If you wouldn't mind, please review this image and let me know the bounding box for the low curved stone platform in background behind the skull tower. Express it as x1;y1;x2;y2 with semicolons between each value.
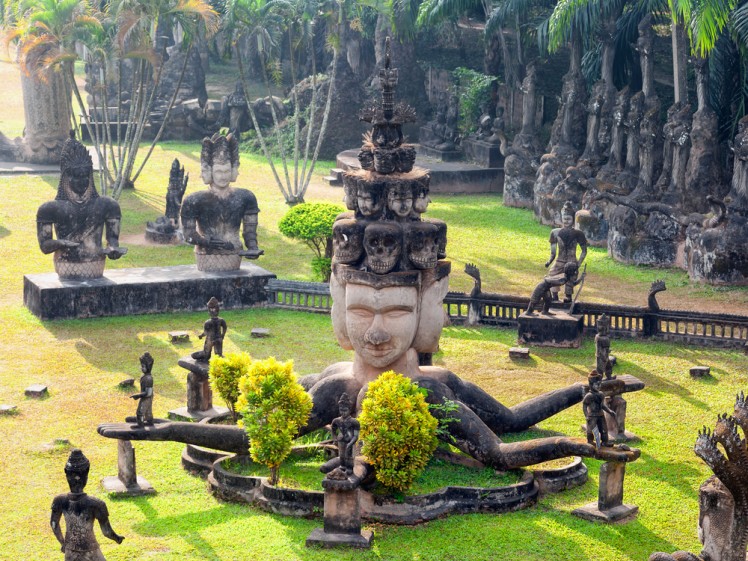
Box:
336;146;504;193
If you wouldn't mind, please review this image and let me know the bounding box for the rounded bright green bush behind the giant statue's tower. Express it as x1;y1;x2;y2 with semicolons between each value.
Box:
278;203;344;282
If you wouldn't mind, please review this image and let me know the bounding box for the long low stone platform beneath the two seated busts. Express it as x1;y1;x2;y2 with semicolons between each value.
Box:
23;262;275;320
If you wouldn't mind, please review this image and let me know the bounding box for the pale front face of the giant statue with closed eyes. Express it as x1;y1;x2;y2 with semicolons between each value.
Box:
345;283;418;368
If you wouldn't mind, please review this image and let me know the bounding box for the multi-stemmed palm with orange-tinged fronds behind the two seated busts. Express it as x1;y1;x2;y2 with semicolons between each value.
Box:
8;0;218;198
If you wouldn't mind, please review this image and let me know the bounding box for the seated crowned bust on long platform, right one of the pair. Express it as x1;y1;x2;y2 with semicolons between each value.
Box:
181;134;264;271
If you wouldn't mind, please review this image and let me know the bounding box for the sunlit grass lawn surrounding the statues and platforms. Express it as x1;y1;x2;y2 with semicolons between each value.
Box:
0;49;748;561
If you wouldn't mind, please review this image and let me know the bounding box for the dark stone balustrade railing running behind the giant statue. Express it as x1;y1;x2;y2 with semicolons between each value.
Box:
266;279;748;347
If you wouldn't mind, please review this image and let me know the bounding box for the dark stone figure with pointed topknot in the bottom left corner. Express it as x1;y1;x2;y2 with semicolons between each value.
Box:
49;449;125;561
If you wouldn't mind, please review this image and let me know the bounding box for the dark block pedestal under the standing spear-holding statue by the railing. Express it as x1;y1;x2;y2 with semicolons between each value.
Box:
517;310;584;349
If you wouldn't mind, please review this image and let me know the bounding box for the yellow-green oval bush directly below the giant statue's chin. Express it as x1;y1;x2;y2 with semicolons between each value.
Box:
358;371;438;491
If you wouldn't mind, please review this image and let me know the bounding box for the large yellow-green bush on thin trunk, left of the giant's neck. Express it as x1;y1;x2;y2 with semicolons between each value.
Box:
236;357;312;485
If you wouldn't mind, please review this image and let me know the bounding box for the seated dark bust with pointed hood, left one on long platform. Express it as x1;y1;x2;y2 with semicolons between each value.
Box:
36;134;127;279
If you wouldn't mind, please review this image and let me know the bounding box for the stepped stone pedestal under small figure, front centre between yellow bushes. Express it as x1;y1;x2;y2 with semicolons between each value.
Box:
306;478;374;548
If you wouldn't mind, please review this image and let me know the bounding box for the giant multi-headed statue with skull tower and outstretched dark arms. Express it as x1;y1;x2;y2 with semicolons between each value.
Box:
99;37;642;469
